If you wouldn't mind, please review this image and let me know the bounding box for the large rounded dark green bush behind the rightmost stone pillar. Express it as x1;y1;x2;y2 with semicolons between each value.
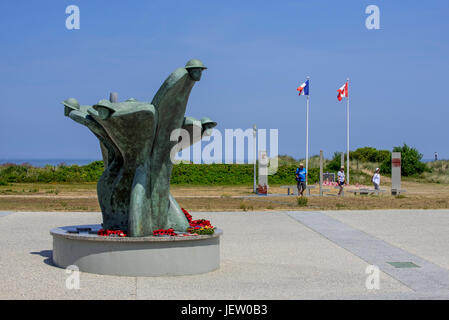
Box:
380;143;429;177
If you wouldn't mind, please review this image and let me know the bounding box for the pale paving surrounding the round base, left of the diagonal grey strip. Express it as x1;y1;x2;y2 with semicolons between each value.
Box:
0;212;412;299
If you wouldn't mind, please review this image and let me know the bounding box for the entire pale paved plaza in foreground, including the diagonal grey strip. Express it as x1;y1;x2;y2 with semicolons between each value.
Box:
0;210;449;299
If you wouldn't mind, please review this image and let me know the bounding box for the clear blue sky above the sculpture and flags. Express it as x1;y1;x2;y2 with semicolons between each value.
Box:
0;0;449;159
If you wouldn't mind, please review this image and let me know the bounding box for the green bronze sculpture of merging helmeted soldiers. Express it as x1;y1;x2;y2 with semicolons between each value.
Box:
63;59;217;237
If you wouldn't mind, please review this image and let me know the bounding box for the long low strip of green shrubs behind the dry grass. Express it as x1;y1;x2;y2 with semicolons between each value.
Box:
0;156;442;186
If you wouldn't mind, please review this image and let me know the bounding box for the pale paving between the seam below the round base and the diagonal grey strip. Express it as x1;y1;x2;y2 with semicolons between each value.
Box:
137;212;411;299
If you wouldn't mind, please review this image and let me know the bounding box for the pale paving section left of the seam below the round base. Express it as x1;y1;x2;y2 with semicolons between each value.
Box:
0;212;136;299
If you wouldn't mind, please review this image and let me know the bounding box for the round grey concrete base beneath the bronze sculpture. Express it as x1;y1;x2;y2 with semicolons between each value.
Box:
50;225;223;277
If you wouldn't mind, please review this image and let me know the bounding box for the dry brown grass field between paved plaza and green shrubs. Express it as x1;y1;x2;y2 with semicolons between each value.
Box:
0;179;449;211
